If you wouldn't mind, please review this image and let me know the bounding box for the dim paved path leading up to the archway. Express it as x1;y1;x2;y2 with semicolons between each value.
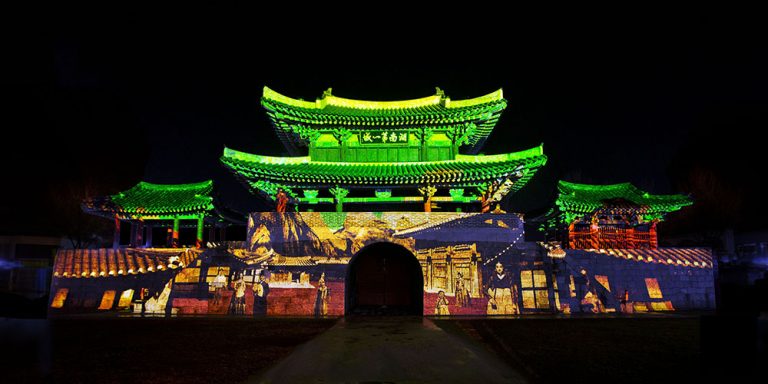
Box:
252;317;526;384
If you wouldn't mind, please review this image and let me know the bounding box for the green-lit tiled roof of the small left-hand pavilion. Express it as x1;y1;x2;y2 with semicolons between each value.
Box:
82;180;214;219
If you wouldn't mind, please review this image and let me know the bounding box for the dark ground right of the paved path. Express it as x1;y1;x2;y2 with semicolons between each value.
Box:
435;315;768;383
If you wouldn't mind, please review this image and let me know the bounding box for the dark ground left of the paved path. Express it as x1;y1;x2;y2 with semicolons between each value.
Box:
0;318;336;383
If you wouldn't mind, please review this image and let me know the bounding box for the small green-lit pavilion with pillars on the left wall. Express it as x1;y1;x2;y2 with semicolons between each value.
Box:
82;180;236;248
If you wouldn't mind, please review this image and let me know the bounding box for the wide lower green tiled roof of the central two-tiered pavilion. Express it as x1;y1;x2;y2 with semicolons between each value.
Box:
221;146;547;192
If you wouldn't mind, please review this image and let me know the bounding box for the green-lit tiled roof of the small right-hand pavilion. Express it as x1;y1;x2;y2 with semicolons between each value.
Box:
555;180;693;215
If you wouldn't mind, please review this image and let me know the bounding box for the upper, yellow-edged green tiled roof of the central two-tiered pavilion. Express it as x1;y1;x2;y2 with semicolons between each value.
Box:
261;87;507;154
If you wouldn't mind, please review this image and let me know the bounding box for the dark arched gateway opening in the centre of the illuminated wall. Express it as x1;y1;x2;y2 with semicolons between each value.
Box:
345;243;424;315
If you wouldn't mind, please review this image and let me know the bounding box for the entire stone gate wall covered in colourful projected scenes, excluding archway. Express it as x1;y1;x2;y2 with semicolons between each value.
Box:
50;212;714;317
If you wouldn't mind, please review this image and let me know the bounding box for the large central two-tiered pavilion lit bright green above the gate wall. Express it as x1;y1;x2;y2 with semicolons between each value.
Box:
221;87;547;211
